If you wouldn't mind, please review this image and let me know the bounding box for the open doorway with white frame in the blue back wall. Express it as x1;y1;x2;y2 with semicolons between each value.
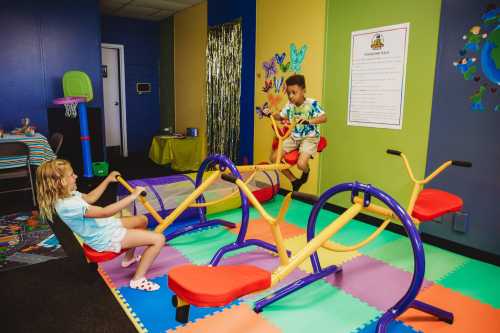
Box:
101;43;128;157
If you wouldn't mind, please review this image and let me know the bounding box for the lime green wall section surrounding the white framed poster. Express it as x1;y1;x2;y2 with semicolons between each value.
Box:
320;0;441;207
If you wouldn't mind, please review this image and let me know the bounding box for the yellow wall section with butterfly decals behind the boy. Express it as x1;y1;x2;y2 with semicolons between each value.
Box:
254;0;328;194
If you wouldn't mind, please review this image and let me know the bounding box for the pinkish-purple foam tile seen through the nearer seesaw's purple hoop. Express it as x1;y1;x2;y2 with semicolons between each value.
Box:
325;255;433;311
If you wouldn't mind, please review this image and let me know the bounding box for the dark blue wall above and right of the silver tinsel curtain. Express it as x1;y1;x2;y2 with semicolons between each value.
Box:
207;0;256;163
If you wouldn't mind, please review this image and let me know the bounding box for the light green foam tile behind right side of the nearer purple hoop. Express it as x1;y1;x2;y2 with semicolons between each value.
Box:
367;237;470;281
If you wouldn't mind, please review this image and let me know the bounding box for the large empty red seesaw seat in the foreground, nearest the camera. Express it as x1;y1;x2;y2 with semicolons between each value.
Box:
168;265;271;307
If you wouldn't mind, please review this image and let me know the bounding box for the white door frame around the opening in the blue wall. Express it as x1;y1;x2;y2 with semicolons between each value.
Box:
101;43;128;157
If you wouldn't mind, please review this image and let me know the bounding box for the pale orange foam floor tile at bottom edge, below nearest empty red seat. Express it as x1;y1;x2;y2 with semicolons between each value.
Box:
167;304;281;333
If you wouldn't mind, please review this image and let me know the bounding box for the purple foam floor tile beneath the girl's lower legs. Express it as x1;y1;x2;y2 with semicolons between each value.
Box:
99;246;189;288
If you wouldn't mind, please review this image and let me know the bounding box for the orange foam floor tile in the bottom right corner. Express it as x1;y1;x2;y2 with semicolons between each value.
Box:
398;281;500;333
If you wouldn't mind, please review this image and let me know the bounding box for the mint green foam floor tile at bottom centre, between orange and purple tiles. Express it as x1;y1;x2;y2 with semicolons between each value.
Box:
261;280;380;333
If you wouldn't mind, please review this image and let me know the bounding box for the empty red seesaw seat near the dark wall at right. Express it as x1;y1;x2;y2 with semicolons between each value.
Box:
412;188;464;222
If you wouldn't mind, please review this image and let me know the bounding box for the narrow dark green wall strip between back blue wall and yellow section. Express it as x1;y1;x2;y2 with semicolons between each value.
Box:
160;16;175;129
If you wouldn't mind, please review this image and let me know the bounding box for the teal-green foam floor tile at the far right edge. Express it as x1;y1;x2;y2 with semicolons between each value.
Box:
438;260;500;309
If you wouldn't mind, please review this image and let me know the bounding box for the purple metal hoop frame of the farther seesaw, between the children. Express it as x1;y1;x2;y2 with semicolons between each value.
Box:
195;154;291;266
